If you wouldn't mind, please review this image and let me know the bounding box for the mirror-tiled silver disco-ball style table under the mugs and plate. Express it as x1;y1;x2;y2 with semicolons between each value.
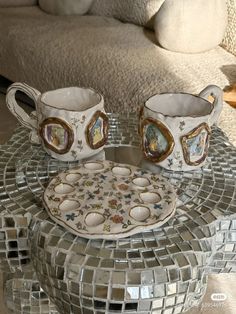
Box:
0;114;236;314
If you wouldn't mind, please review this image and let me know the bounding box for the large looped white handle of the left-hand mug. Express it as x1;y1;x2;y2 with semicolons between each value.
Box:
6;83;41;144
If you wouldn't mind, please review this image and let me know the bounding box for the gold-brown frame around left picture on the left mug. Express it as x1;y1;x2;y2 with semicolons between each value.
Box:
39;117;74;155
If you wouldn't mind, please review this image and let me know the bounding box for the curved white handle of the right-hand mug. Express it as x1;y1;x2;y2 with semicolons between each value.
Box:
199;85;223;126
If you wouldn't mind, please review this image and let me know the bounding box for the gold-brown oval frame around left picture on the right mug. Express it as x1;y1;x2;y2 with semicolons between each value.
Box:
140;118;175;162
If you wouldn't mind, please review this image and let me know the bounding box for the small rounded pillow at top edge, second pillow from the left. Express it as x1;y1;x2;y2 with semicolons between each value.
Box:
39;0;93;15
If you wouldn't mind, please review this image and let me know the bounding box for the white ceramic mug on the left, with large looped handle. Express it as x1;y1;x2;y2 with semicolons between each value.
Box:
6;83;108;161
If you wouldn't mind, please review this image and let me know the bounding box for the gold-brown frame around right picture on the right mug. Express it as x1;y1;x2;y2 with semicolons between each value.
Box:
180;122;211;166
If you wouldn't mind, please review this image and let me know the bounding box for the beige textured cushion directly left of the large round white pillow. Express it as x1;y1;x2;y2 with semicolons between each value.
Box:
90;0;165;28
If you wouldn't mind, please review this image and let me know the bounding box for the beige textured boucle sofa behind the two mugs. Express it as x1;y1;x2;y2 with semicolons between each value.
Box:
0;0;236;112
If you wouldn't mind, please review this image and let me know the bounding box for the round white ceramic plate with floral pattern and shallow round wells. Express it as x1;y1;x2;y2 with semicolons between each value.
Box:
44;161;177;239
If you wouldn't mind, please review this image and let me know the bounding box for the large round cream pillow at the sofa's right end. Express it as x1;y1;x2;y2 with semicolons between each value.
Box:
154;0;227;53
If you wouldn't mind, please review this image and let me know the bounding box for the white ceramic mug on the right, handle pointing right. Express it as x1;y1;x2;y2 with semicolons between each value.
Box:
139;85;223;171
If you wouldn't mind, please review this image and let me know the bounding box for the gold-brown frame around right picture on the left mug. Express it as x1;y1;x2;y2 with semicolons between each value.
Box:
85;110;109;149
